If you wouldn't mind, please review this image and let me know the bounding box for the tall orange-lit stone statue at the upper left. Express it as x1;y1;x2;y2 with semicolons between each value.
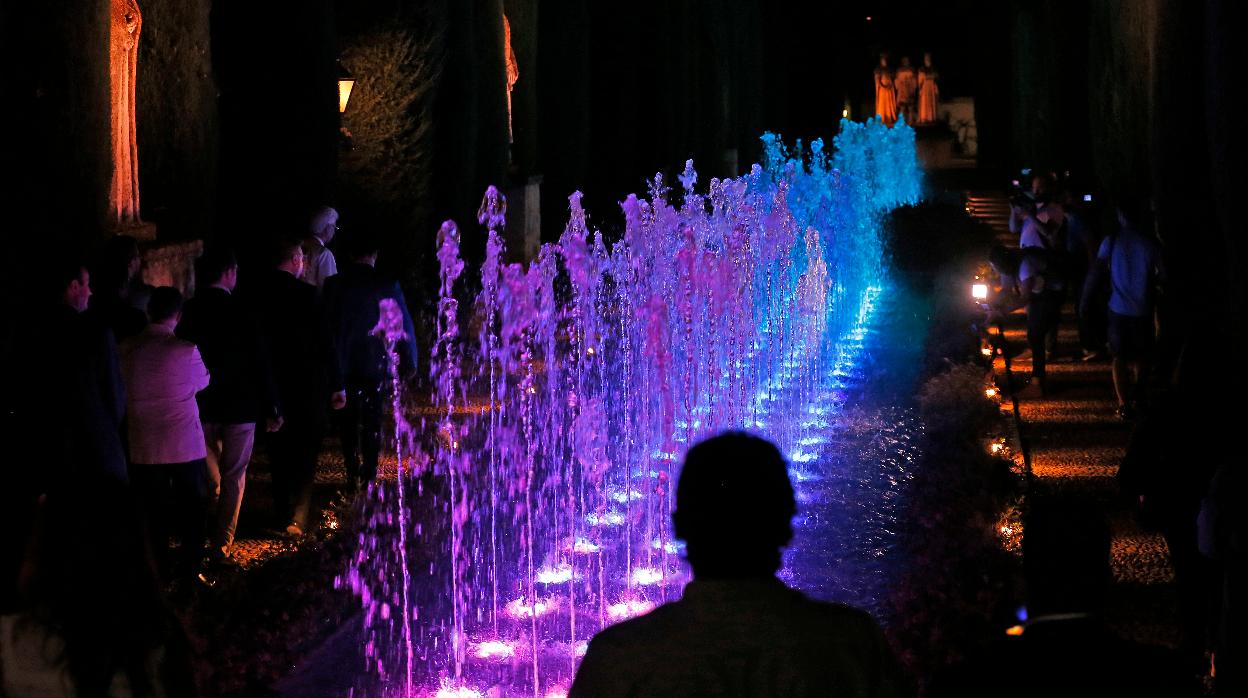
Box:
109;0;144;230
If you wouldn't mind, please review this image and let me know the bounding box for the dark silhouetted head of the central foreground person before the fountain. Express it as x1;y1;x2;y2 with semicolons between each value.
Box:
671;432;797;579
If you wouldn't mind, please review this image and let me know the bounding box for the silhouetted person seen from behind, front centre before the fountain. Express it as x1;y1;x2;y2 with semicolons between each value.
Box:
569;432;896;698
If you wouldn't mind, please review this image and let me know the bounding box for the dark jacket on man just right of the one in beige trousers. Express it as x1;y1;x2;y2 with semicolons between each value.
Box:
247;270;343;428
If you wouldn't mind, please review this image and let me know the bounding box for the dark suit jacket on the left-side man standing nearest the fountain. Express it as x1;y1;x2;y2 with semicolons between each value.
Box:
324;262;416;383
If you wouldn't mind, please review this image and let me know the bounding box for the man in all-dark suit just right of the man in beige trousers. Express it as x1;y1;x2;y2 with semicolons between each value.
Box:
245;241;347;536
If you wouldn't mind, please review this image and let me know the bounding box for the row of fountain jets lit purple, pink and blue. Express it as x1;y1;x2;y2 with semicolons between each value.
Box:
341;121;919;698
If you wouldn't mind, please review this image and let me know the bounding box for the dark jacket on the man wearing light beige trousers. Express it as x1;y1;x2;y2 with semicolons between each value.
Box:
177;286;277;425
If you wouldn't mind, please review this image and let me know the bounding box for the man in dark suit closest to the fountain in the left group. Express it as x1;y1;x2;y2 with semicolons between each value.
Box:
324;233;416;492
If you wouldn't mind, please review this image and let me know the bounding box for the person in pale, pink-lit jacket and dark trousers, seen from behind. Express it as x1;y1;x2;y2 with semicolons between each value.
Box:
121;286;210;577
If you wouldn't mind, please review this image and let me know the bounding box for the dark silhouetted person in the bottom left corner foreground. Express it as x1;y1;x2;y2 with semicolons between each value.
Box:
0;483;197;698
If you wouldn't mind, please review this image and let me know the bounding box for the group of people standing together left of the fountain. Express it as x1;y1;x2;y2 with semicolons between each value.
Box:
0;209;416;696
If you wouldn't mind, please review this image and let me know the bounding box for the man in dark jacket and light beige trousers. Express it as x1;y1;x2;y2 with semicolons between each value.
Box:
177;247;282;564
